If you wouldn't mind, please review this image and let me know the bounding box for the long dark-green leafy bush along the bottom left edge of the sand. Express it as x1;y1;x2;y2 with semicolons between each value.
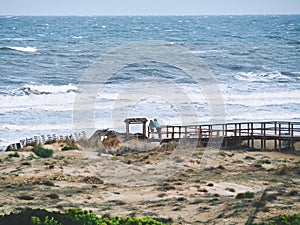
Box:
0;209;169;225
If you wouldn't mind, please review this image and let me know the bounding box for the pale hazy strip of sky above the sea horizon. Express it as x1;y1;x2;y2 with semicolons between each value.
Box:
0;0;300;16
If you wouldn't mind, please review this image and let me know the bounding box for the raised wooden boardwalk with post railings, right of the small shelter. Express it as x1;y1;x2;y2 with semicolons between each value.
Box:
148;121;300;150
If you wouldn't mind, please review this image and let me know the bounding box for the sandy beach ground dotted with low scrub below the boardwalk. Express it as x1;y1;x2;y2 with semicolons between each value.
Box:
0;136;300;224
